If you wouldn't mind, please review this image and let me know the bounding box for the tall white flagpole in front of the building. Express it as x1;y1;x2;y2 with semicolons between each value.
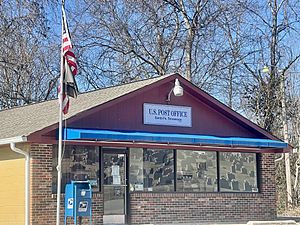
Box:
56;0;64;225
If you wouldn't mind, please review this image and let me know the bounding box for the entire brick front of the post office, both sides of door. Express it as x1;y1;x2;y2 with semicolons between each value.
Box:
30;144;276;225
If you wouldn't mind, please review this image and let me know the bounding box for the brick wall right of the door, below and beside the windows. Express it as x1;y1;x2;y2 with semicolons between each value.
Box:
130;154;276;224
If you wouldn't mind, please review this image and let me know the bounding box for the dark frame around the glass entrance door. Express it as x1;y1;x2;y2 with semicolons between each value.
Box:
99;146;130;224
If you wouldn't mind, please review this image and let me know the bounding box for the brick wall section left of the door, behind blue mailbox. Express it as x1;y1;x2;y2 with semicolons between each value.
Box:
30;144;103;225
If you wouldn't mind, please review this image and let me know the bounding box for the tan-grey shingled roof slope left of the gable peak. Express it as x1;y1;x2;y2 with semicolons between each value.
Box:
0;75;170;144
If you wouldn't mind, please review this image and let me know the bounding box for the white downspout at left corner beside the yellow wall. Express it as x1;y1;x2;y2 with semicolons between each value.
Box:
10;142;30;225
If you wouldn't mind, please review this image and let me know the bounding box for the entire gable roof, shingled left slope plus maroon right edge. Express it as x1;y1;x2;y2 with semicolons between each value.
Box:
0;74;291;151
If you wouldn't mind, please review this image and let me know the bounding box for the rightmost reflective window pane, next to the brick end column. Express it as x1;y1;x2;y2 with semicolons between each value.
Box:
219;152;258;192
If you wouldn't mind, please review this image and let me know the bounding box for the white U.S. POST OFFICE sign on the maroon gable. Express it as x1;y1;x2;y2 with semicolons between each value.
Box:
144;103;192;127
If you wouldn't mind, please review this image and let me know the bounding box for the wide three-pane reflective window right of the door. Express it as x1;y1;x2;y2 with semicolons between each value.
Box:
129;148;258;192
